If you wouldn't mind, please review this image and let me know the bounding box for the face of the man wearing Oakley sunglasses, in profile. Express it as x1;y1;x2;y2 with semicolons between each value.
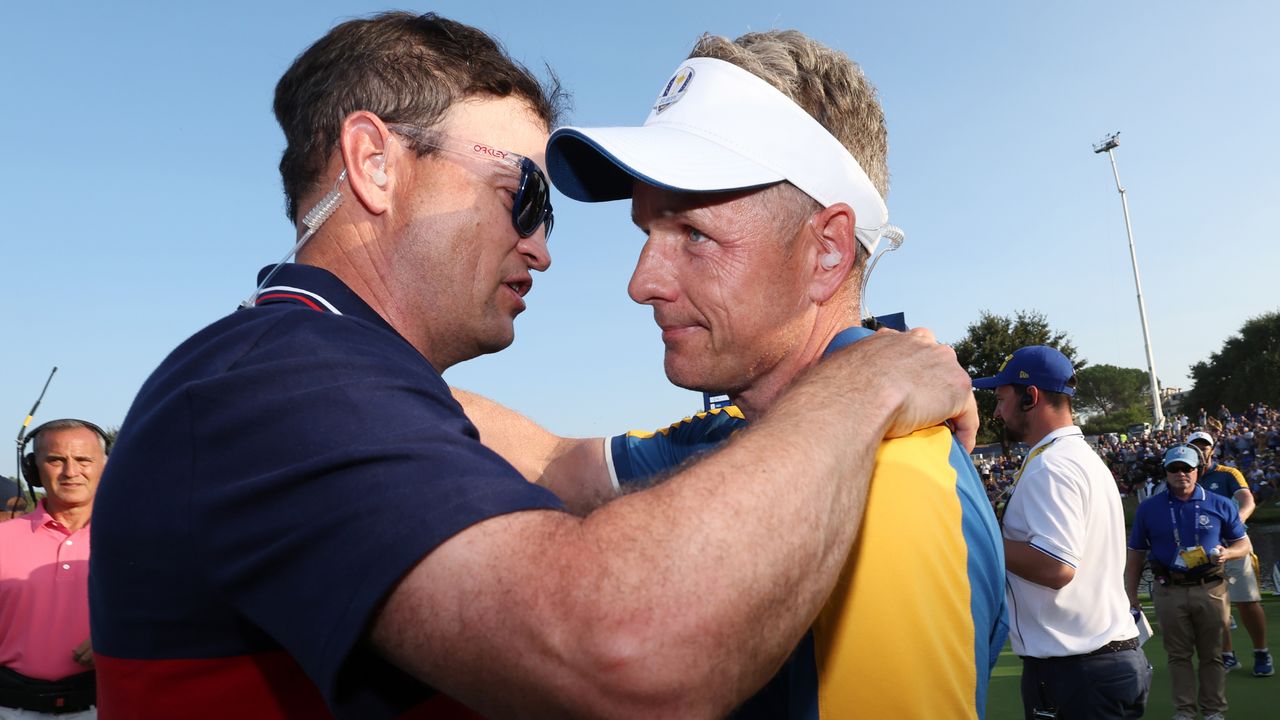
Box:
384;97;550;370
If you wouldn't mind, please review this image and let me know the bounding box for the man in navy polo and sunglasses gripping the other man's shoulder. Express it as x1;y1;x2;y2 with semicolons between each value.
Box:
90;13;975;720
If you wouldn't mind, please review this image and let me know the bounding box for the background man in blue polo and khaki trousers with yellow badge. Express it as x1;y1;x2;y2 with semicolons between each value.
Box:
1124;445;1253;720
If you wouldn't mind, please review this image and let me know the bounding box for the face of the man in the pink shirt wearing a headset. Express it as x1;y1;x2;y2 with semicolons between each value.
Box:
35;428;106;514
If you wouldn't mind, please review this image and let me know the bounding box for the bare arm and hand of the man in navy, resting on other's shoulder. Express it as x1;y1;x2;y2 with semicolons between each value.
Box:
372;334;972;717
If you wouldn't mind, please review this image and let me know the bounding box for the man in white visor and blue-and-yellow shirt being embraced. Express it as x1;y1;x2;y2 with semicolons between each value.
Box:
463;31;1007;719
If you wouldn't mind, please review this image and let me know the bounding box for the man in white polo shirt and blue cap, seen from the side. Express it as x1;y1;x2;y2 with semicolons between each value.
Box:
973;345;1151;720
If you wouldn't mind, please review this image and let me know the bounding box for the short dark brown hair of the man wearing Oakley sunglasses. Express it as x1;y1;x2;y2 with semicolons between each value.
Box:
274;12;566;220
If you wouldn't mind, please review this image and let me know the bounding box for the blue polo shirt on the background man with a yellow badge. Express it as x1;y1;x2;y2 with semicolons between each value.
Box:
1129;486;1244;574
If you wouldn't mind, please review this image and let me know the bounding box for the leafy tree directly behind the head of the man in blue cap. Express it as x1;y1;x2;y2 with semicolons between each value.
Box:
954;310;1085;443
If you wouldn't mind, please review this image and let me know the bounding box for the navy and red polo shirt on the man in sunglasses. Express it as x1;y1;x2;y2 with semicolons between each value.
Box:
90;265;561;719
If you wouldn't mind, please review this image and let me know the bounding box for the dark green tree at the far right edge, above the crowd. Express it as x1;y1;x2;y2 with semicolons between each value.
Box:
1183;311;1280;413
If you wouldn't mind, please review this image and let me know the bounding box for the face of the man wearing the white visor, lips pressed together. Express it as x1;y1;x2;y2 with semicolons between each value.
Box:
627;182;812;395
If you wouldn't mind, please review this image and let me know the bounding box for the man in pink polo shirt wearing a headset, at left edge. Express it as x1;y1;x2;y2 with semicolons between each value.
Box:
0;420;108;720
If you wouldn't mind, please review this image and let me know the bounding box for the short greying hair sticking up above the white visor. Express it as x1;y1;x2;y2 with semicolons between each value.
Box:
689;29;888;197
